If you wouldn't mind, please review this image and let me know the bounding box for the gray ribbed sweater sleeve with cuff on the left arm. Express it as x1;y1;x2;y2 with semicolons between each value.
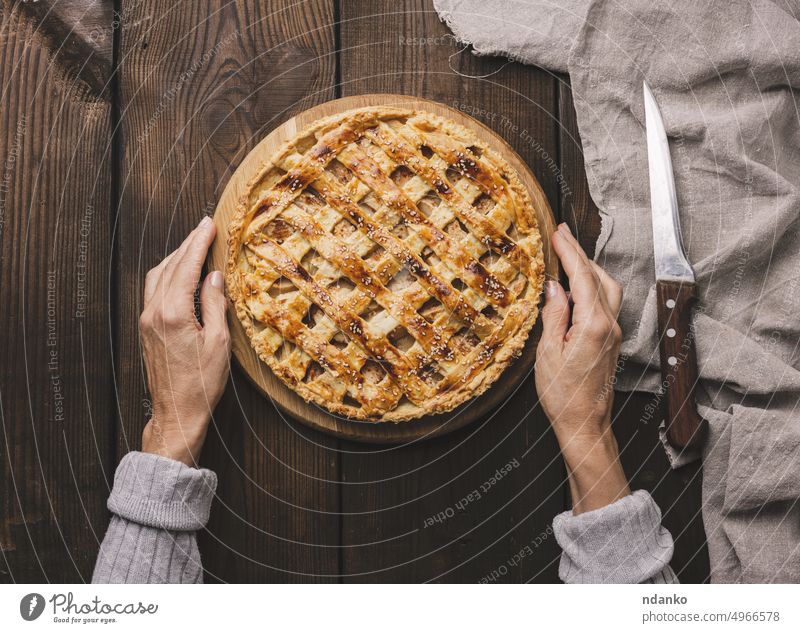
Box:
92;452;217;583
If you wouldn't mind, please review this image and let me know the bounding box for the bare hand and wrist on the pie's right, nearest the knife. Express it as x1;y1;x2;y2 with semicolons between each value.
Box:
536;224;630;514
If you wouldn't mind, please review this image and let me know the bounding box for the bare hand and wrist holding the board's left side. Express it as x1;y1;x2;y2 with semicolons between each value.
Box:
139;218;231;466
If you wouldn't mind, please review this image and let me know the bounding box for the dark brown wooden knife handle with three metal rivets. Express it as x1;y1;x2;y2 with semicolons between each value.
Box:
656;281;708;449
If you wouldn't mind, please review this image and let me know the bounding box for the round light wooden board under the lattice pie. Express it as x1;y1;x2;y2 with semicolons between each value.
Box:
209;94;558;443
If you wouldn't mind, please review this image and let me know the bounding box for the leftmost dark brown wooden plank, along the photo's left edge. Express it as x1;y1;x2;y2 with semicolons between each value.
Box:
0;0;113;583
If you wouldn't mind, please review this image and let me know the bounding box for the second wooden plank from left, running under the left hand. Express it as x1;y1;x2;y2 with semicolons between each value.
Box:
117;0;339;582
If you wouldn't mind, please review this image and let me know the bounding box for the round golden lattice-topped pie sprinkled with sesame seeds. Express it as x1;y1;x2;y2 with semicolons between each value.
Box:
227;107;544;421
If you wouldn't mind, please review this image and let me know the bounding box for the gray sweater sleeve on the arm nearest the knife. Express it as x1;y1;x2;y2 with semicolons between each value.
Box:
553;490;678;584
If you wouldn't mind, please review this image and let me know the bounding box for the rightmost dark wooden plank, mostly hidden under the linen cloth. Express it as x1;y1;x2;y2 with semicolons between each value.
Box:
559;77;709;583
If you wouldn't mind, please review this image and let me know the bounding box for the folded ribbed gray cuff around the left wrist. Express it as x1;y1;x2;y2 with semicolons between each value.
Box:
108;452;217;531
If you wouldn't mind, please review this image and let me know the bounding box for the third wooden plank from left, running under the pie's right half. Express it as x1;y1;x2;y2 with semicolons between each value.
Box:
340;0;564;582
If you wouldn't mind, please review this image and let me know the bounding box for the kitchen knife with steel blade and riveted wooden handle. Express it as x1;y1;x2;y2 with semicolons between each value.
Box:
644;82;708;449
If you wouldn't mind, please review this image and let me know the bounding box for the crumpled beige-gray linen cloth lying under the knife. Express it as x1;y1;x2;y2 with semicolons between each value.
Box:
435;0;800;582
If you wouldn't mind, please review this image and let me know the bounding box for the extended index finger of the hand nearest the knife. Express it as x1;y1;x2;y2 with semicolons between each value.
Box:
552;224;609;323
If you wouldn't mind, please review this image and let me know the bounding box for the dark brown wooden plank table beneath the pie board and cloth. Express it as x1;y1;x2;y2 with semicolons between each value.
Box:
0;0;708;582
